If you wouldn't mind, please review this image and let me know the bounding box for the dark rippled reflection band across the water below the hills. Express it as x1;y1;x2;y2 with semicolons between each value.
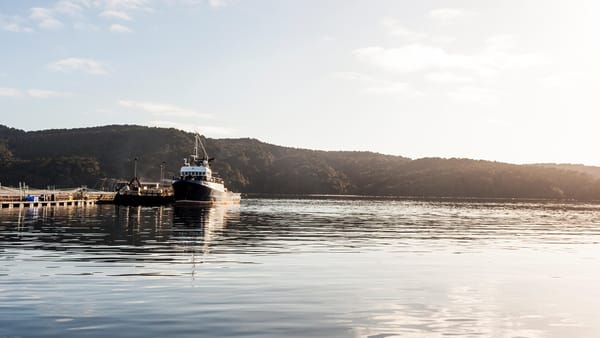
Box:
0;200;600;260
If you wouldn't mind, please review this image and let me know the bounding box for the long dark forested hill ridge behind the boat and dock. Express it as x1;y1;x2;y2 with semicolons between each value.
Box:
0;125;600;200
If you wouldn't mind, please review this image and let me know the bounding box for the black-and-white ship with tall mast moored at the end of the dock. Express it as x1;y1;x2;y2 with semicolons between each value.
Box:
172;133;241;206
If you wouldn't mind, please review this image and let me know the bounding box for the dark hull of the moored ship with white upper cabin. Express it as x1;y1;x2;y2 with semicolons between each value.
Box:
173;180;240;205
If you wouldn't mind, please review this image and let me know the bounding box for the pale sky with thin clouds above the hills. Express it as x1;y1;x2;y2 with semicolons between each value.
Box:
0;0;600;165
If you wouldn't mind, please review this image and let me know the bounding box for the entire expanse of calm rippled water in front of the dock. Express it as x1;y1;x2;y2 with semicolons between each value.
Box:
0;199;600;337
